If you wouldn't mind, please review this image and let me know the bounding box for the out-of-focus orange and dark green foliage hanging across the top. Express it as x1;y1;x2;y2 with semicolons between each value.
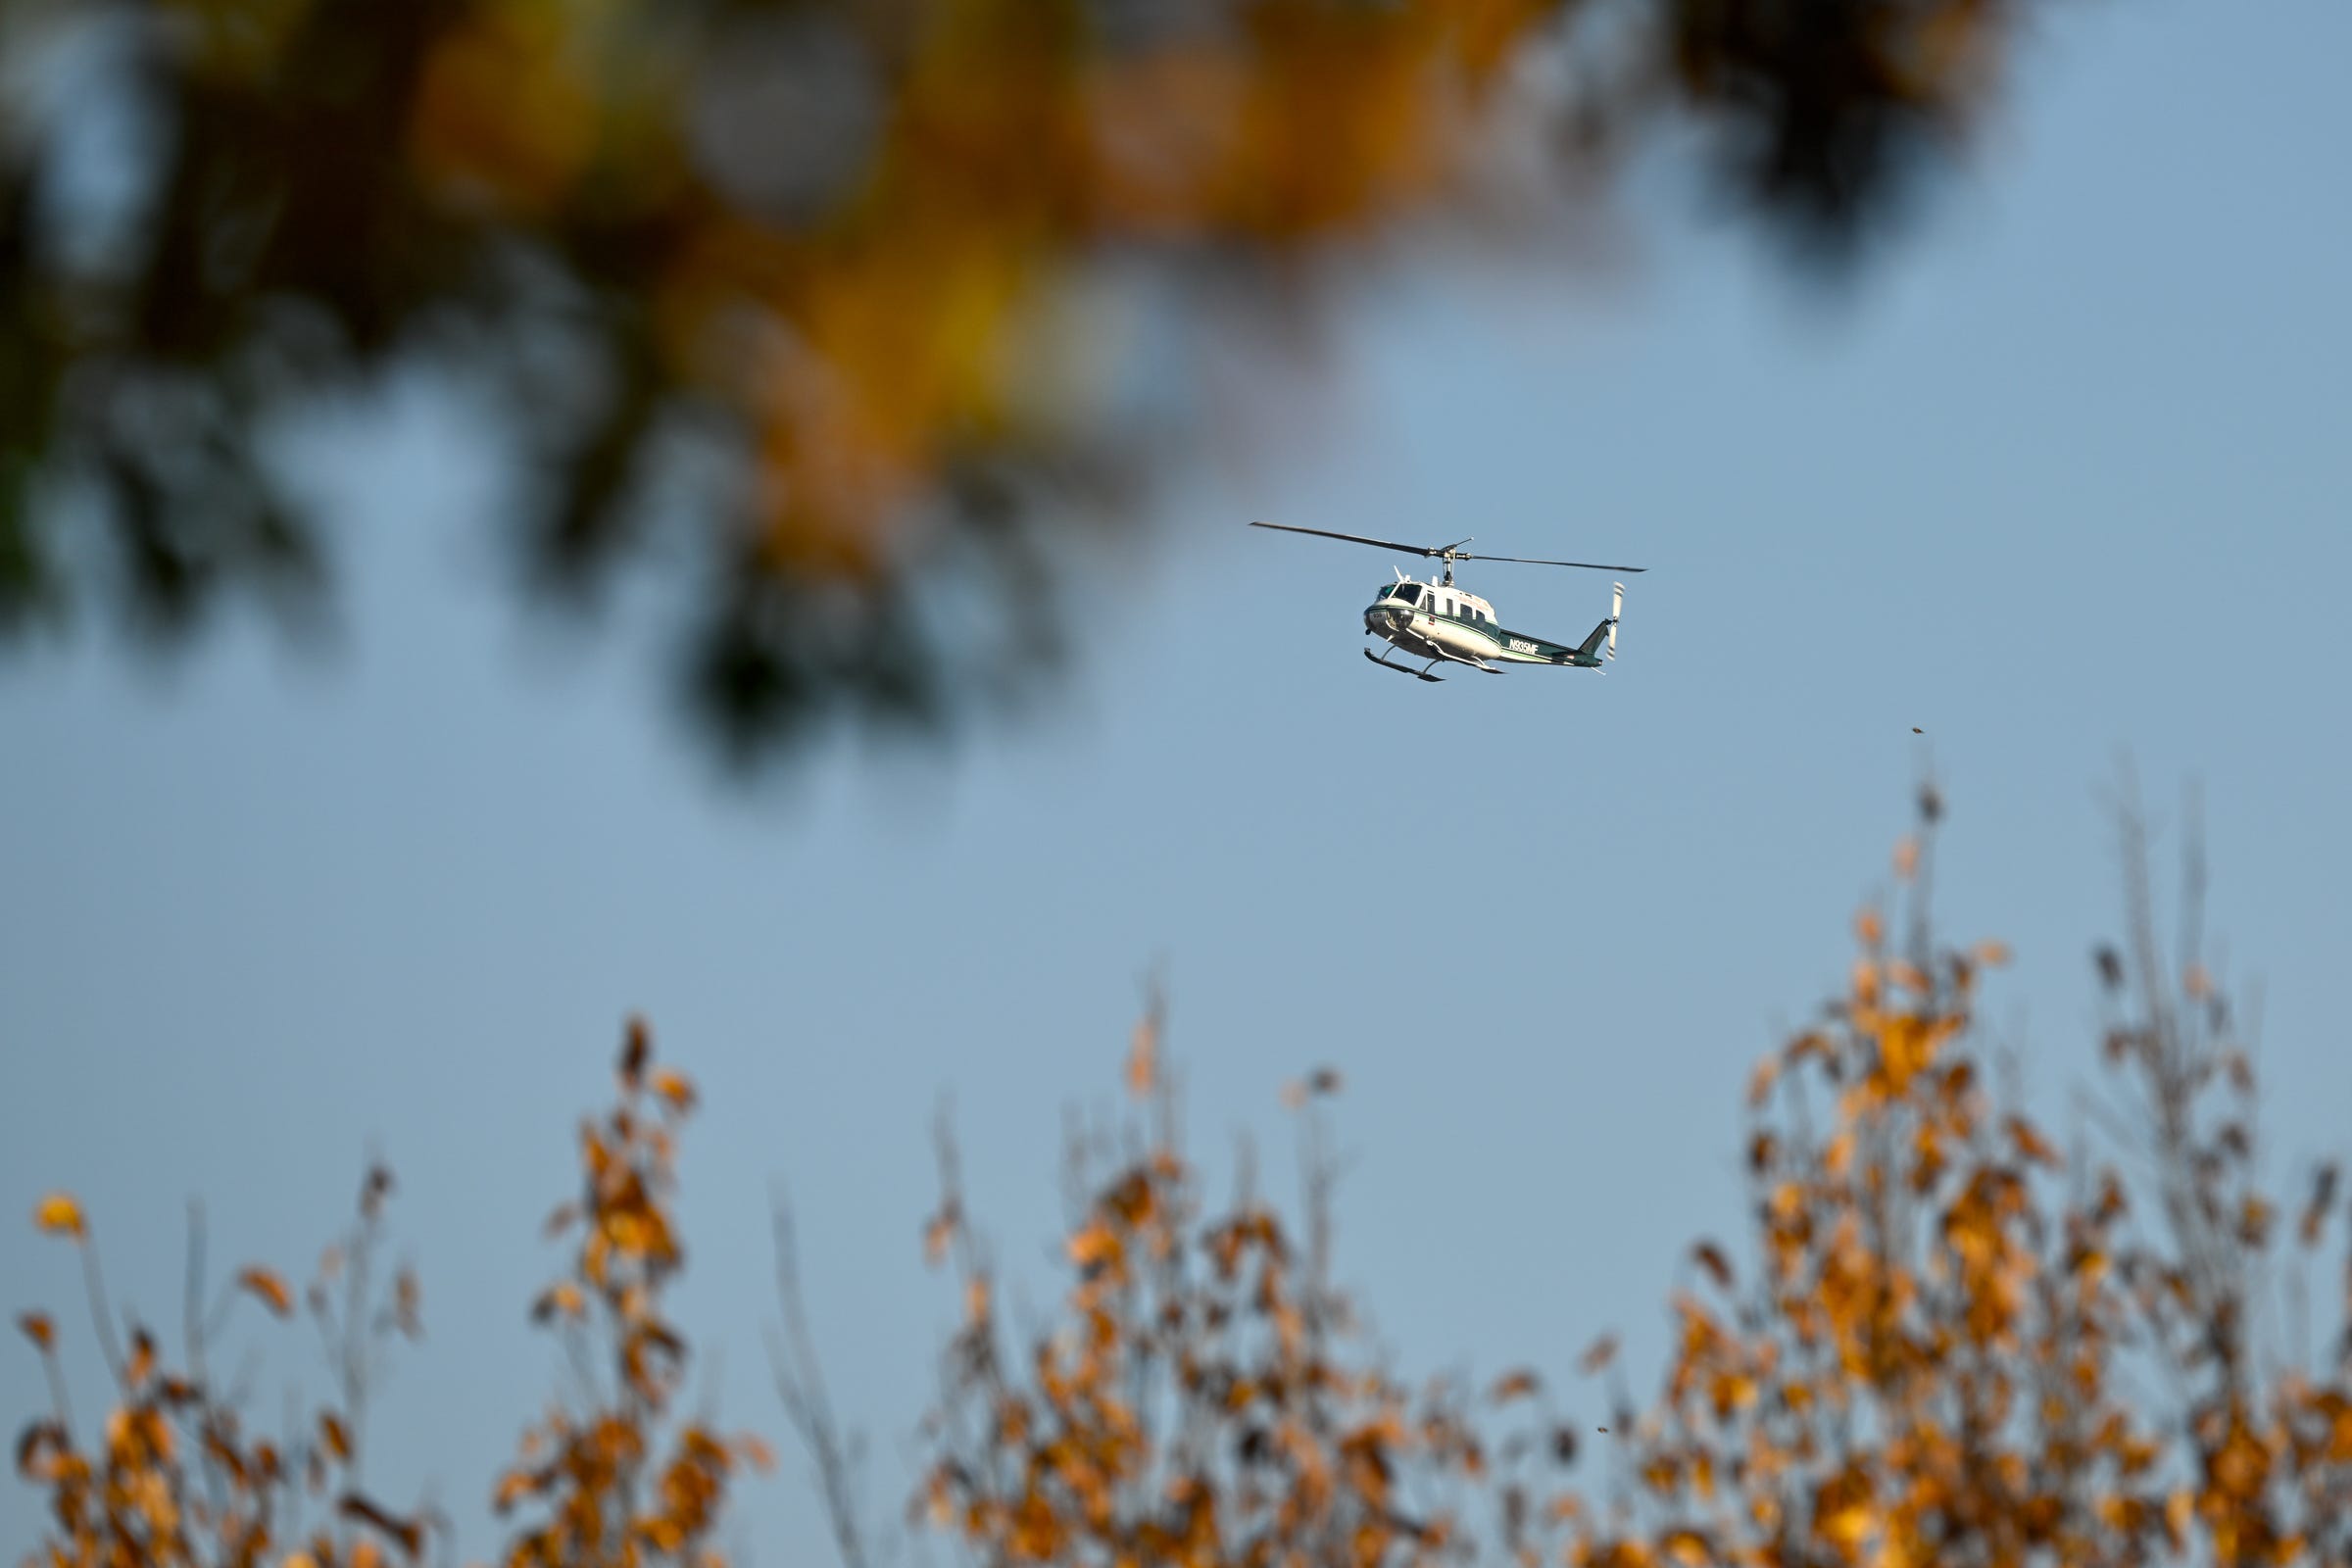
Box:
0;0;2028;757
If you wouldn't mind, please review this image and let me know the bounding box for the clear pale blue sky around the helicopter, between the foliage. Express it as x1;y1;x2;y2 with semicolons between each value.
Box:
0;0;2352;1561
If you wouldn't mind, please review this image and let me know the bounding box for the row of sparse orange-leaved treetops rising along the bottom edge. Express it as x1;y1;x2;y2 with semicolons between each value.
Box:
17;795;2352;1568
